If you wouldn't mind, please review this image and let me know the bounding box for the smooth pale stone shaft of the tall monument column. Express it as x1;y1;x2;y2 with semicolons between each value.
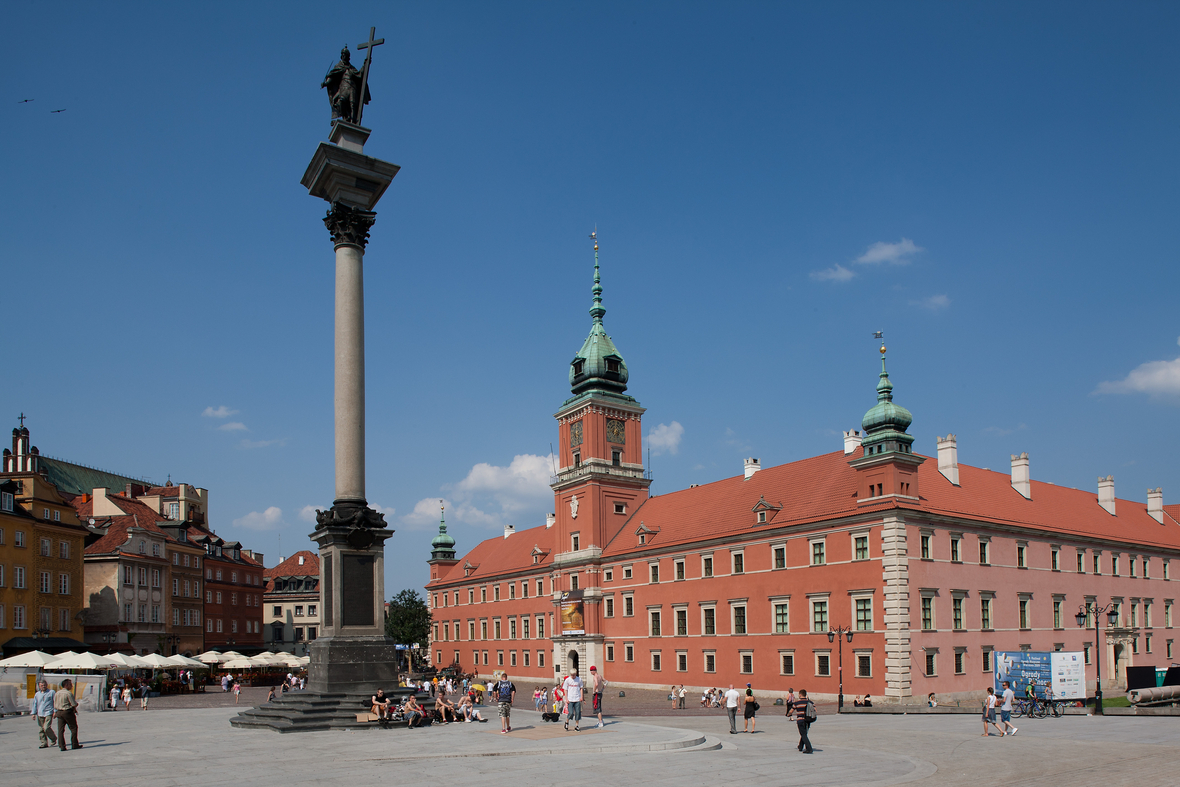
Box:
335;243;365;504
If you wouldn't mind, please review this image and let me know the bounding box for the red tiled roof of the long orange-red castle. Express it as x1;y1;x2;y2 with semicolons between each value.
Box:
438;452;1180;586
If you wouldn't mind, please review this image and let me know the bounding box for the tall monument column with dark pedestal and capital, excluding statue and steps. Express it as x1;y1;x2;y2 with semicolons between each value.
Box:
302;110;399;695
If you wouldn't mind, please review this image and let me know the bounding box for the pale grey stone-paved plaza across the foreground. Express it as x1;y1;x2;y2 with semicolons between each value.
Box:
0;708;1180;787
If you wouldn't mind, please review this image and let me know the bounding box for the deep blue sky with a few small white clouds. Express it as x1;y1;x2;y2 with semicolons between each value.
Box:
0;2;1180;592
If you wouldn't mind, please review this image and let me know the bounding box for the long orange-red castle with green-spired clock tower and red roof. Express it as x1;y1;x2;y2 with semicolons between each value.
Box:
426;247;1180;702
